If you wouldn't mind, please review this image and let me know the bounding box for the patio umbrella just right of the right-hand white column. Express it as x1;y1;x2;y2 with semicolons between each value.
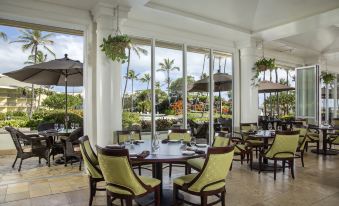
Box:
258;81;294;116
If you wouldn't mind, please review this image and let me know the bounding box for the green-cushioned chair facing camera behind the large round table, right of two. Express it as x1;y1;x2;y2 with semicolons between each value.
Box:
167;129;192;177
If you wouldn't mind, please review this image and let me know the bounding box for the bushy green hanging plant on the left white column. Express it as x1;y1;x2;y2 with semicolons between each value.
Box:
100;35;131;63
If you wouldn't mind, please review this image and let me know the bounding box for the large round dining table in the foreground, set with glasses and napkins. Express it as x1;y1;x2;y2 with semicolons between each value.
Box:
125;140;208;206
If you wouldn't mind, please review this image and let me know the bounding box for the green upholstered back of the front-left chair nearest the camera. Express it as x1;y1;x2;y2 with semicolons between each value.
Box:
98;153;146;195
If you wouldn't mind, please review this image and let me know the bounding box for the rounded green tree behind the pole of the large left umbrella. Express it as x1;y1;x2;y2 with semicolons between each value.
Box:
42;93;83;109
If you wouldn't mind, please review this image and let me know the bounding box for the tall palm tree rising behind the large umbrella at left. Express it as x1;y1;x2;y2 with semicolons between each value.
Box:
10;29;55;117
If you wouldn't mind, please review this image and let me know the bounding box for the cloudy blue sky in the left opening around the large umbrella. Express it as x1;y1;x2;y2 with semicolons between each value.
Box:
0;25;84;92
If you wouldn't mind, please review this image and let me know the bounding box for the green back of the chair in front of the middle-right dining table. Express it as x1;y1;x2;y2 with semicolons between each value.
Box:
265;134;299;158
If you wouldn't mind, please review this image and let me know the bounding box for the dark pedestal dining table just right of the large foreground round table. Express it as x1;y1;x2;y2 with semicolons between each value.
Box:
249;130;275;171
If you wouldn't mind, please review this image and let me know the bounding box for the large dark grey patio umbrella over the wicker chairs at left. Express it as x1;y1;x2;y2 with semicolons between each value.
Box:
4;54;83;128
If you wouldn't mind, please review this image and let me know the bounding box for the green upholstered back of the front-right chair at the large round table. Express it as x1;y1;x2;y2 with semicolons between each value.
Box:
188;150;234;192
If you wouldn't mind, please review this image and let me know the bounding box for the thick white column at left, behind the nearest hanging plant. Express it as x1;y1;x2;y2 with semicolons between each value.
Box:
93;2;122;146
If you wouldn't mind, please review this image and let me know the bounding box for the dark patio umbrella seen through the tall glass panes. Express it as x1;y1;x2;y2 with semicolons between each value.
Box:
188;72;232;115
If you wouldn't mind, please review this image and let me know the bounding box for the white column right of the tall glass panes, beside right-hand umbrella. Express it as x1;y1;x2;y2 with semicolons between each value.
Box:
240;43;258;123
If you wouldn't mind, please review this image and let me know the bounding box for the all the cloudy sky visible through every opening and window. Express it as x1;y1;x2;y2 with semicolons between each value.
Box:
0;25;294;104
